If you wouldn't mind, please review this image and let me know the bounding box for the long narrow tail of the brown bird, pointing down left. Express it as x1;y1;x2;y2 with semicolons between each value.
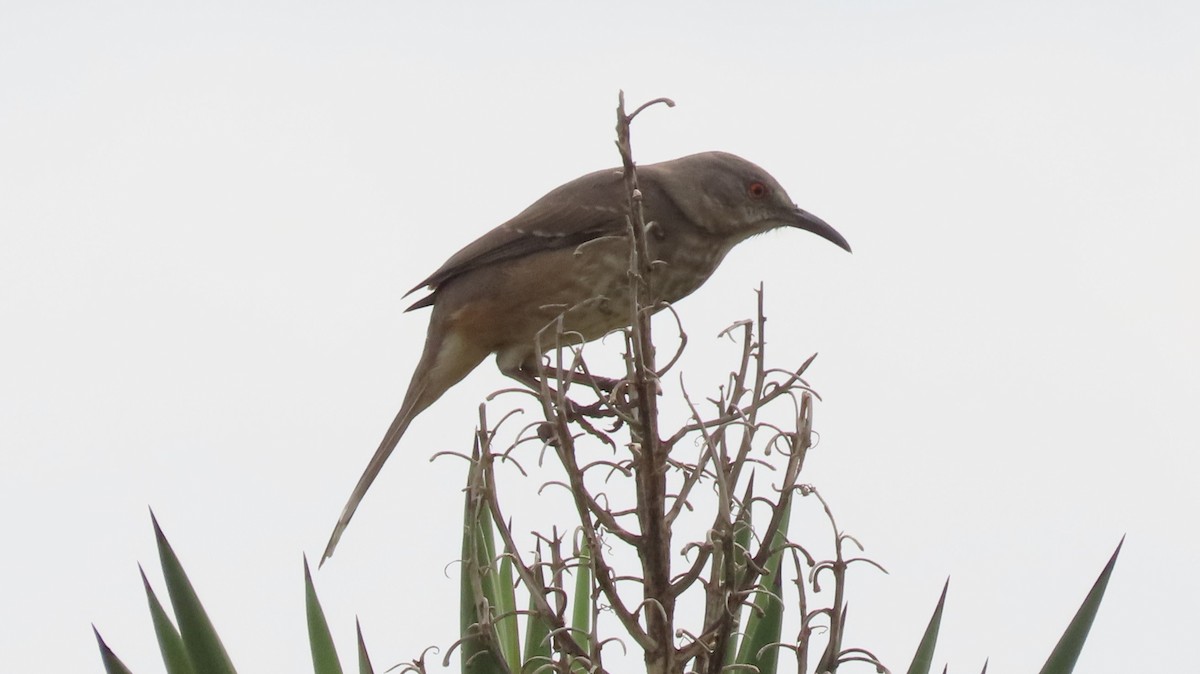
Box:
318;317;487;567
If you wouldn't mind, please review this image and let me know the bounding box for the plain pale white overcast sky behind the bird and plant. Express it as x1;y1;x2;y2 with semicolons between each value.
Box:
0;0;1200;673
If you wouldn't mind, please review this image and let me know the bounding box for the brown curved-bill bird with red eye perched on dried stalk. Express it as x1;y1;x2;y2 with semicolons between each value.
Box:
320;151;851;564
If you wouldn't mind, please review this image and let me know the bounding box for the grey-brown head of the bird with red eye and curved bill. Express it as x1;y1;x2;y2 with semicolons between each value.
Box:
638;152;850;251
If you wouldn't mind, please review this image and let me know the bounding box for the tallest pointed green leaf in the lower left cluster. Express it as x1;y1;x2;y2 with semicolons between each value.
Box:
150;512;236;674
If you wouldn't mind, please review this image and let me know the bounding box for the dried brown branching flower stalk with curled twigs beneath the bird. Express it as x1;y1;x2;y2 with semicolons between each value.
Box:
444;96;886;674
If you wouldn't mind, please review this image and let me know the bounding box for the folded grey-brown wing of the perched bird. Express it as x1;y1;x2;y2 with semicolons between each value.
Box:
407;169;626;311
